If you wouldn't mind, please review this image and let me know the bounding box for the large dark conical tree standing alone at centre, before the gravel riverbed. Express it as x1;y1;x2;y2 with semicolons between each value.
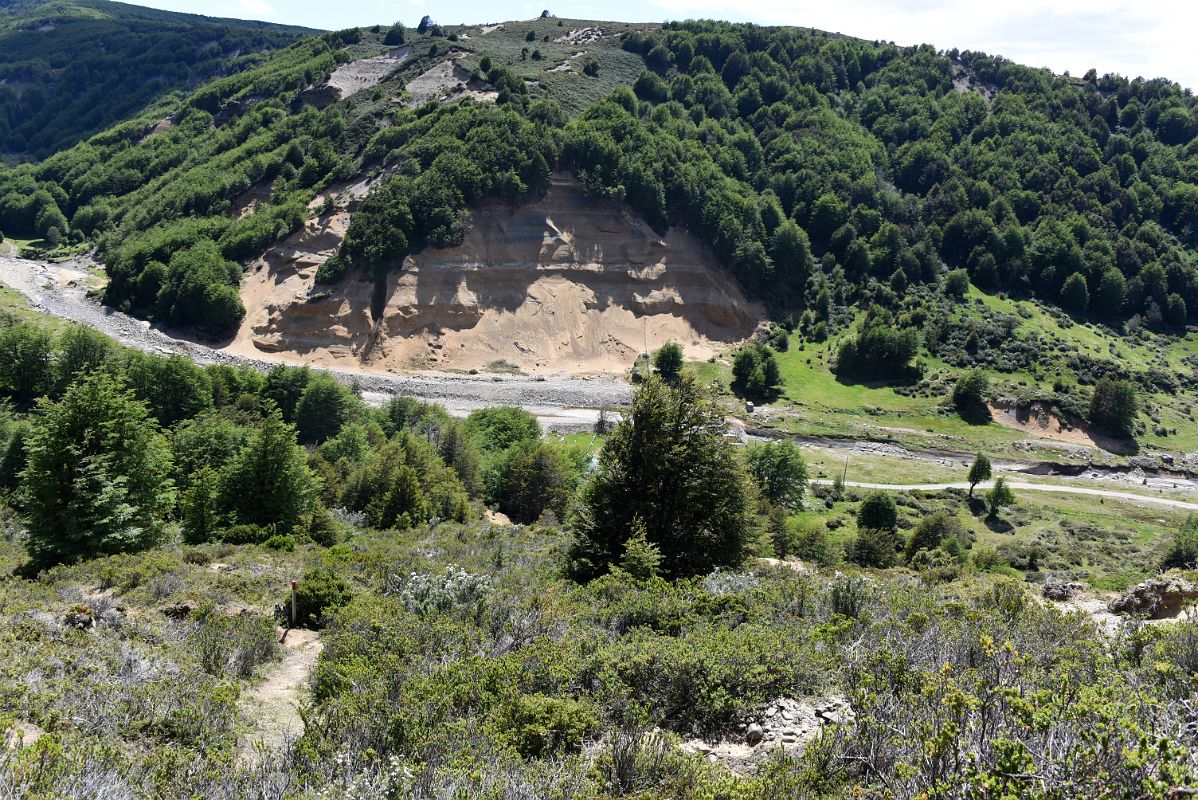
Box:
571;376;757;577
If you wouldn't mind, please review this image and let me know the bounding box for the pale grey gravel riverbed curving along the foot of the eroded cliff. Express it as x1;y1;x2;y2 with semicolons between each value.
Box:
0;253;633;431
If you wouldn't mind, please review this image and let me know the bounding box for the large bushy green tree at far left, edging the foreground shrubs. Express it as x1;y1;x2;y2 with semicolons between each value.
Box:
22;372;175;565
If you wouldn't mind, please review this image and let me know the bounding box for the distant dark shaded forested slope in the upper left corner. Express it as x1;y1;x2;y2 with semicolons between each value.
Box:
0;0;310;158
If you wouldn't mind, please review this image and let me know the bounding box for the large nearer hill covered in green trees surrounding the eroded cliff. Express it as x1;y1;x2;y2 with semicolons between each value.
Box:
0;19;1198;349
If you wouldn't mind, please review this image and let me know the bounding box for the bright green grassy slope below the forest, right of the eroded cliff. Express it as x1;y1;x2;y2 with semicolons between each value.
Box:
688;282;1198;463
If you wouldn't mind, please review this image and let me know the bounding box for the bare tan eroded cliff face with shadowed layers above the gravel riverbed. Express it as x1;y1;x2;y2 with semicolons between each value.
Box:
232;175;764;372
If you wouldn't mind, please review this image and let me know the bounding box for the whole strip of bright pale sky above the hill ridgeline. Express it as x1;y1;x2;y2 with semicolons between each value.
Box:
137;0;1198;91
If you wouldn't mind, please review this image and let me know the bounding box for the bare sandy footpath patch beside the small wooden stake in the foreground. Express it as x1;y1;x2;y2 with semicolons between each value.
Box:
237;629;325;764
